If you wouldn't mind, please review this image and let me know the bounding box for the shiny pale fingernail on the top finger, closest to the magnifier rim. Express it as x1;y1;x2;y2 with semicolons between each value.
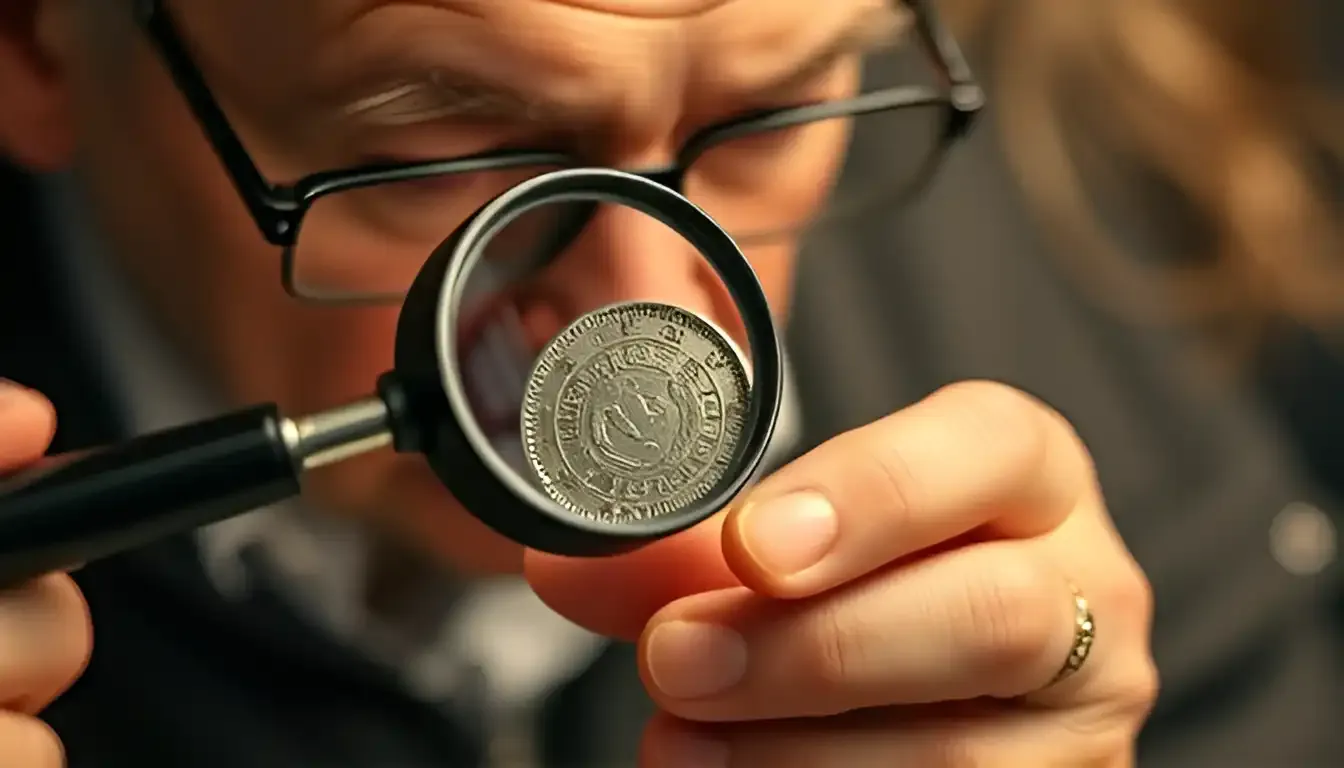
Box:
739;491;840;576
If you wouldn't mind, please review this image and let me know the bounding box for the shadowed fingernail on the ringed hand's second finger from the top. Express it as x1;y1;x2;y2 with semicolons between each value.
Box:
648;621;747;698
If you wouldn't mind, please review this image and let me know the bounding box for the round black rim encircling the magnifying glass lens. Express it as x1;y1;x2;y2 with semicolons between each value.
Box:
435;168;784;539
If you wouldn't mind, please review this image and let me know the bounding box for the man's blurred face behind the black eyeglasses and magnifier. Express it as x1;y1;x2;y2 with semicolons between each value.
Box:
0;0;890;569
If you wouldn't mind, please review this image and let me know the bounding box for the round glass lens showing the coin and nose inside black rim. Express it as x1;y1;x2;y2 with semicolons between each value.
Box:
457;202;750;525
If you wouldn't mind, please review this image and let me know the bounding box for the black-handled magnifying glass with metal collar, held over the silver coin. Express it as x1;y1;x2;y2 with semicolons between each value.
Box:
0;168;782;584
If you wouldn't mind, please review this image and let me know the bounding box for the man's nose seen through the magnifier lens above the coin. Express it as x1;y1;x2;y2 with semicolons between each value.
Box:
518;203;723;330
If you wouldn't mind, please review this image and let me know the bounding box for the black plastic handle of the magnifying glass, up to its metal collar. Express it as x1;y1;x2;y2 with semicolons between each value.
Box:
0;405;301;585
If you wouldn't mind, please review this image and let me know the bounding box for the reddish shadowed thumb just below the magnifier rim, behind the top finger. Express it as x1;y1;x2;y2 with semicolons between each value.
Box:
523;512;738;640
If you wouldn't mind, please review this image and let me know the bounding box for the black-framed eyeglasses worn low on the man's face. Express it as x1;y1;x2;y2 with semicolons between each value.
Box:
136;0;984;303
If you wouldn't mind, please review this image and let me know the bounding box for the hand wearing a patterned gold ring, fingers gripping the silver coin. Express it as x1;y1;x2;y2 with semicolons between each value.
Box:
527;382;1156;768
